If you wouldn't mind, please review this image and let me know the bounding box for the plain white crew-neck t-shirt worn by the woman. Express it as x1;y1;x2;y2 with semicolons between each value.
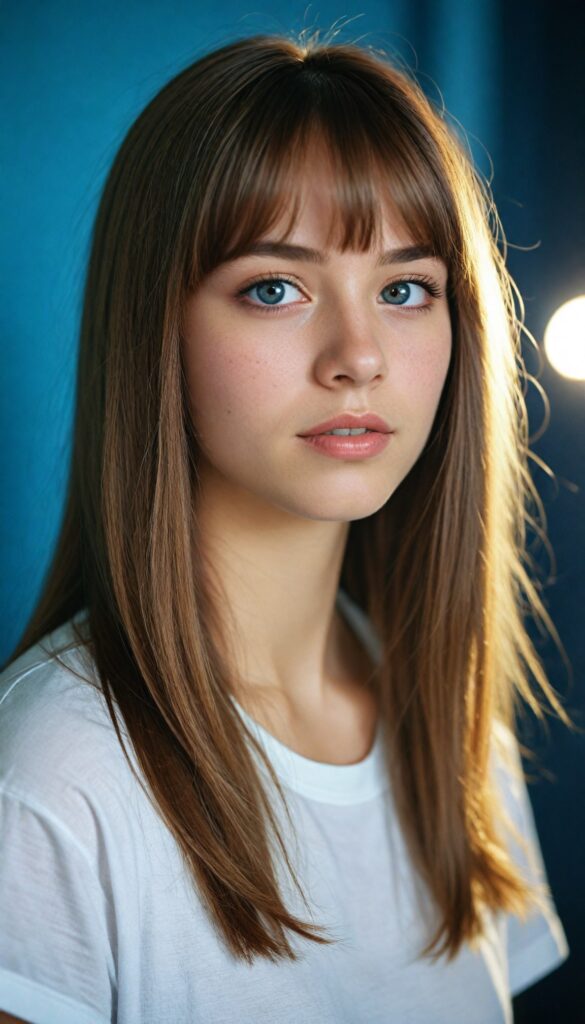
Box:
0;591;569;1024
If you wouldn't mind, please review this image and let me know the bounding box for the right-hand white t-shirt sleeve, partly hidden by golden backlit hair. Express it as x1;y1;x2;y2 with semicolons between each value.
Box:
491;730;570;995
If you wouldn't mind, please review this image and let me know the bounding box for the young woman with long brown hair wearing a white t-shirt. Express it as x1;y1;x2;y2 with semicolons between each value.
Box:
0;28;571;1024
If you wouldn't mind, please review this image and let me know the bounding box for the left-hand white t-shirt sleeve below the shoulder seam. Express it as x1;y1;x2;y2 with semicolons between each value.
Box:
0;792;116;1024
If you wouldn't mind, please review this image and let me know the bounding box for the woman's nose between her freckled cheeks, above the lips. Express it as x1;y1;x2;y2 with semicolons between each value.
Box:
315;303;387;387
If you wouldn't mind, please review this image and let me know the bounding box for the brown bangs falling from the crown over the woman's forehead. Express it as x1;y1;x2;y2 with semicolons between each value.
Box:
187;57;462;290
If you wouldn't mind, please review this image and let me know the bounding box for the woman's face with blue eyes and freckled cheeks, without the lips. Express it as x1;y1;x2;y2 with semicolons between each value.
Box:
183;163;452;522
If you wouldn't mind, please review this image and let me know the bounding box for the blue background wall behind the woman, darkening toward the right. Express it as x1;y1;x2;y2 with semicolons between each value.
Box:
0;0;585;1024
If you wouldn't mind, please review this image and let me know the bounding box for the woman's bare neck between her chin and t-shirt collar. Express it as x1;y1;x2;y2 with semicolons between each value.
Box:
197;468;350;707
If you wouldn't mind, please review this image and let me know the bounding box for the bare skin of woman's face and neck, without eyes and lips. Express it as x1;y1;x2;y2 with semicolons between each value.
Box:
183;153;452;751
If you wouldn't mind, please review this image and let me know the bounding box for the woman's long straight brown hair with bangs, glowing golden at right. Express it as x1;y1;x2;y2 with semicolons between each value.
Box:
3;28;573;963
